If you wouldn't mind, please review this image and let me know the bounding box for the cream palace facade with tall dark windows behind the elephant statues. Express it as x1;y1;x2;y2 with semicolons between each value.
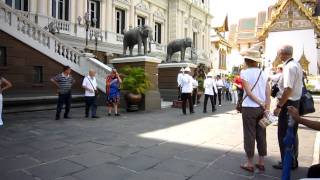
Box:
2;0;213;65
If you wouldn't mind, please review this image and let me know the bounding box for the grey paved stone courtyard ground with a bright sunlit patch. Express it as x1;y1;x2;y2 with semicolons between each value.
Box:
0;101;318;180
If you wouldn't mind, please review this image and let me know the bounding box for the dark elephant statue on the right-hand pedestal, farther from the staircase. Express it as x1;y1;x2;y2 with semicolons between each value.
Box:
166;37;192;62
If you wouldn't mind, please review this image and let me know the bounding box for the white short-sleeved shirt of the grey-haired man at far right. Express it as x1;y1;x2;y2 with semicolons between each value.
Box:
281;59;303;101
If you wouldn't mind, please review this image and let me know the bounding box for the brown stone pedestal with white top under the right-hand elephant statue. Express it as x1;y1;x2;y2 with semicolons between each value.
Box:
158;63;197;103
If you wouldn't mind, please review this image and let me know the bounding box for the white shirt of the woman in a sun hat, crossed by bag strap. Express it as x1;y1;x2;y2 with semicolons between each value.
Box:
241;68;268;107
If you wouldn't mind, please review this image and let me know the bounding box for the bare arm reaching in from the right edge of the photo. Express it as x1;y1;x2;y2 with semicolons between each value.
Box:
288;106;320;131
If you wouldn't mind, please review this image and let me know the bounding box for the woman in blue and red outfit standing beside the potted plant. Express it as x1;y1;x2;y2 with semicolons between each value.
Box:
106;68;122;116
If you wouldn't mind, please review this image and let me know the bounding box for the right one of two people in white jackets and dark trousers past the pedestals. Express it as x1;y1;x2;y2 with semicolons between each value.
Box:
203;72;218;113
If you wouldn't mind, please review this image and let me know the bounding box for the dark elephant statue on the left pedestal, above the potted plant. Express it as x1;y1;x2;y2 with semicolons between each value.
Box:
123;25;153;56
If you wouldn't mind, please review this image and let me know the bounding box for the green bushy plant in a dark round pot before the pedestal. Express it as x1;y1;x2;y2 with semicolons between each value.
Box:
120;66;151;112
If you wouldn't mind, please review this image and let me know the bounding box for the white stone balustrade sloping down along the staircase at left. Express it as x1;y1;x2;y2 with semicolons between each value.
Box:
0;1;111;92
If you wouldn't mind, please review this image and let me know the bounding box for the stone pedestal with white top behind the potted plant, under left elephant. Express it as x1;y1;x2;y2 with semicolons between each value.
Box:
111;56;161;111
